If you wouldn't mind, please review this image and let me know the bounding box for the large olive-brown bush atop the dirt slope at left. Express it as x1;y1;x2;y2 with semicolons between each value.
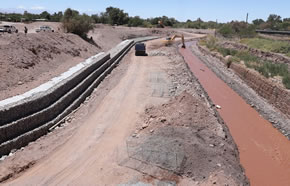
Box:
62;8;94;39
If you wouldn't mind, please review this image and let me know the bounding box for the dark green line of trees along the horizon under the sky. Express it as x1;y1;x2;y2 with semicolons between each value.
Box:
0;7;290;37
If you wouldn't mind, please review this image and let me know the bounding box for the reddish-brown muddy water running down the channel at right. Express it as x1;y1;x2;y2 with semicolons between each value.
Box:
180;42;290;186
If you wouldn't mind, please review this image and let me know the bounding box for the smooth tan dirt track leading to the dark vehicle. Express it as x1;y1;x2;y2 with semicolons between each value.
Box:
3;41;174;185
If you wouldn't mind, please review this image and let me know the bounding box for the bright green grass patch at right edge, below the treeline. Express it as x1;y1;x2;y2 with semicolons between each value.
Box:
241;37;290;57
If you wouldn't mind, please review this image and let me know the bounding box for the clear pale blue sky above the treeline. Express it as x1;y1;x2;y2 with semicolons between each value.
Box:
0;0;290;22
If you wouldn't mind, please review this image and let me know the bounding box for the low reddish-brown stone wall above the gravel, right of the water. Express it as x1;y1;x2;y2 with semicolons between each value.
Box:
198;46;290;116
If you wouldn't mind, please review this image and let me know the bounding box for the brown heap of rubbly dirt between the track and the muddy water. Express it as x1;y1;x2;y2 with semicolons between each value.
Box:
127;92;247;185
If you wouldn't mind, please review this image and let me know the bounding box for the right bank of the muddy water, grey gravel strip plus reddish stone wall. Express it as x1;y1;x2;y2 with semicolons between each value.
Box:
192;42;290;139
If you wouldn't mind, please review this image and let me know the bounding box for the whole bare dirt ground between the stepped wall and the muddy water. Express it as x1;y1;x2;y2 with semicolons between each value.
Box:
0;40;248;185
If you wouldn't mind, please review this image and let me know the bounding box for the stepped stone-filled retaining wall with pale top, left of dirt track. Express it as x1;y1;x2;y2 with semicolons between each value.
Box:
0;37;156;157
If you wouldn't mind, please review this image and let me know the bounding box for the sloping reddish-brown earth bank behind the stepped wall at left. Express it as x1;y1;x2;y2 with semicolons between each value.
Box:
0;33;99;100
